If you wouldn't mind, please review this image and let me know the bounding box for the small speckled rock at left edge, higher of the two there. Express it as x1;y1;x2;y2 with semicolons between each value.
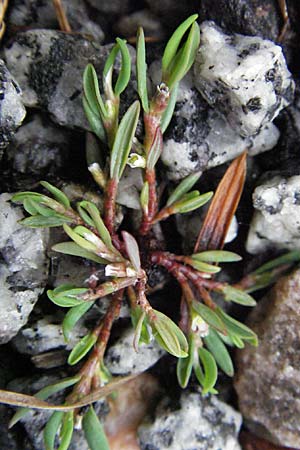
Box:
0;59;26;158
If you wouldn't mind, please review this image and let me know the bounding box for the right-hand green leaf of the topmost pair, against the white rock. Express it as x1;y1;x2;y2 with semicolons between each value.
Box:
163;22;200;89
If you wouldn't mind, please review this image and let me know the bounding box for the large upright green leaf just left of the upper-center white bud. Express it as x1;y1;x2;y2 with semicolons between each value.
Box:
110;101;140;181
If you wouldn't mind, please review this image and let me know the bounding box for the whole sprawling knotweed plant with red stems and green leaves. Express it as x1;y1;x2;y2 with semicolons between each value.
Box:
1;15;299;450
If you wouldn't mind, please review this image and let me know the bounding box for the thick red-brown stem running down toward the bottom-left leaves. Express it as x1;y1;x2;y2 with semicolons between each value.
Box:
67;289;124;402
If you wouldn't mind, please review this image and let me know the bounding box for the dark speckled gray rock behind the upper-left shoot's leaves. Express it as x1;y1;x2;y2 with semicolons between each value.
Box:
5;30;135;129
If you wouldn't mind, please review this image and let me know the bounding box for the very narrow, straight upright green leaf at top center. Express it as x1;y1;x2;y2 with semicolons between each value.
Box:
136;27;149;113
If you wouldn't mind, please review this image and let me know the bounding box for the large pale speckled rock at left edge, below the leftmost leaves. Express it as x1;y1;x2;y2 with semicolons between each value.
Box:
0;194;48;344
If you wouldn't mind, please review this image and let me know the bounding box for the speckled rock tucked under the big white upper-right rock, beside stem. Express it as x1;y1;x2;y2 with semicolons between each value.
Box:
159;68;279;180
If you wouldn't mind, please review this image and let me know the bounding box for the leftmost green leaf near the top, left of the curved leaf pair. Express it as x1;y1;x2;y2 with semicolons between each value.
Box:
83;64;107;120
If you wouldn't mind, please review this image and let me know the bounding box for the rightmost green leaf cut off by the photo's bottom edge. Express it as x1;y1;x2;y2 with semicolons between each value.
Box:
82;406;109;450
